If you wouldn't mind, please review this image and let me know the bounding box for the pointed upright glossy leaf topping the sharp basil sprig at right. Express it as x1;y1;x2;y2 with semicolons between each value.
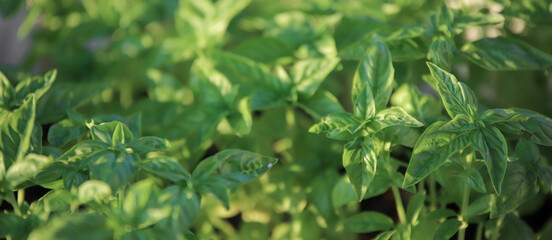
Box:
427;62;477;119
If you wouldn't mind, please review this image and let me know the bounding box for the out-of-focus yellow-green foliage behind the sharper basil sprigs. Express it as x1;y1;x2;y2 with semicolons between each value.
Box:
0;0;552;239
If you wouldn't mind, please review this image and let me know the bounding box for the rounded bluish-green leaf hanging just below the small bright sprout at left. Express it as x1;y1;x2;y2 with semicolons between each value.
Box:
90;152;137;190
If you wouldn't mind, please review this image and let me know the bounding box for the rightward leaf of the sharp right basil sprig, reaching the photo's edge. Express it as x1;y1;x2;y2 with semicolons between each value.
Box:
481;108;552;146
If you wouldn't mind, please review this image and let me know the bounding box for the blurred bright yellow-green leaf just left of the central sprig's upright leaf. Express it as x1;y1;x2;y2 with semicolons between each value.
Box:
291;58;339;98
